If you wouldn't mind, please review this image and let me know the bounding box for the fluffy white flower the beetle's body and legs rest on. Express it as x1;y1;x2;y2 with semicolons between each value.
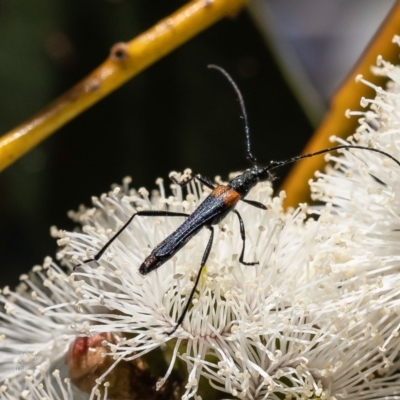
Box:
57;162;400;399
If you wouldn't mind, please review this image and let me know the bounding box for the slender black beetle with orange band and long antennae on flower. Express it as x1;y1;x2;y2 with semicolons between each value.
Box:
75;65;400;335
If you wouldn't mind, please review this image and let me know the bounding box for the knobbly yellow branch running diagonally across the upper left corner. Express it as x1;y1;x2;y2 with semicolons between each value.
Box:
0;0;247;171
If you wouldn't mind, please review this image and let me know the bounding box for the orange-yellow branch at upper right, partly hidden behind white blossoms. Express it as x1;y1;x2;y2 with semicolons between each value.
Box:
282;1;400;206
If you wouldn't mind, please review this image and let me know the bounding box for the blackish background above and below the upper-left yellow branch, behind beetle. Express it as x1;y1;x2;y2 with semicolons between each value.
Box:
0;0;312;286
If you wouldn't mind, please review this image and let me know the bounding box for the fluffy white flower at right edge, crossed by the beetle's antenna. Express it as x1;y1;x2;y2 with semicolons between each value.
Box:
311;38;400;289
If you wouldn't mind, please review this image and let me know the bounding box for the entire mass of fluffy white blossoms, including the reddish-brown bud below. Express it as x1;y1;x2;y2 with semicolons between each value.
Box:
5;39;400;400
